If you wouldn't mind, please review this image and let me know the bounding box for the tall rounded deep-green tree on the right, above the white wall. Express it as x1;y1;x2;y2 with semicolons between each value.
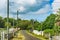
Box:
42;14;56;30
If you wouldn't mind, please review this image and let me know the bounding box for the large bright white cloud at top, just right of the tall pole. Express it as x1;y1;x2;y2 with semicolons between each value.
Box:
10;0;36;12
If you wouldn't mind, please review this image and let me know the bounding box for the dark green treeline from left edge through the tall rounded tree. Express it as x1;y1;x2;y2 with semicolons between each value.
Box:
0;14;56;31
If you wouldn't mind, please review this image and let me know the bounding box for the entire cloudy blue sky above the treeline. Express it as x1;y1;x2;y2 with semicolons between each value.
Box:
0;0;60;21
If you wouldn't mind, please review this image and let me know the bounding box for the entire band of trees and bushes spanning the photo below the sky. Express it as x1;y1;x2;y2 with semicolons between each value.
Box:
0;10;60;39
